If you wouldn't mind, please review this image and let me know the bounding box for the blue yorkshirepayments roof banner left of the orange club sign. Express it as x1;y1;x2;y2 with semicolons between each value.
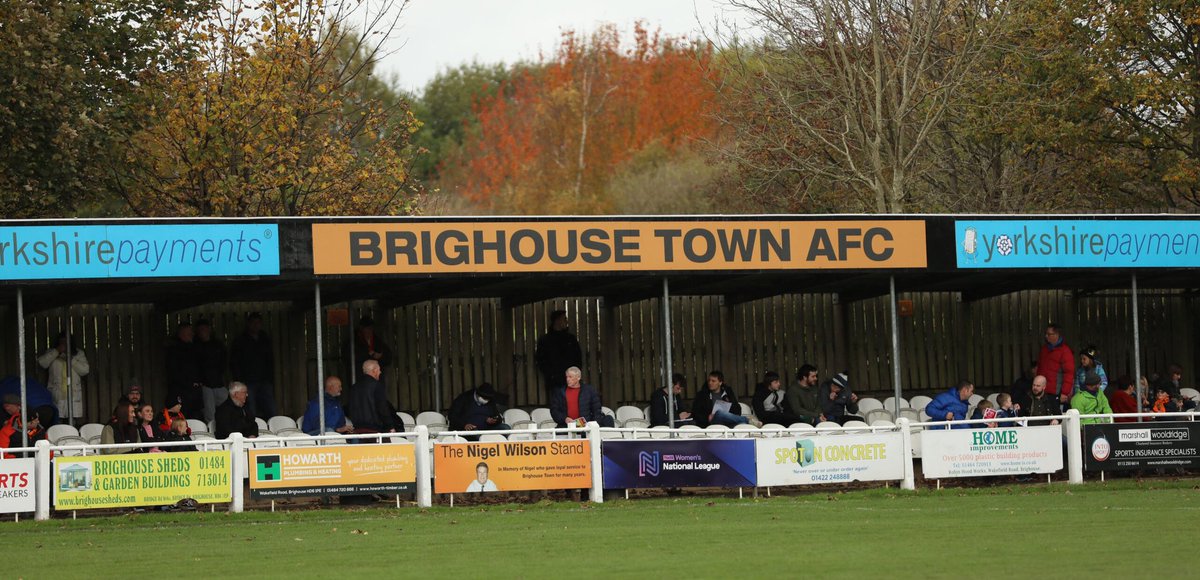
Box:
0;223;280;280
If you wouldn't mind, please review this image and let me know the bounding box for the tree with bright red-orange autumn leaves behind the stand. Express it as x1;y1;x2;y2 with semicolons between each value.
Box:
452;25;715;213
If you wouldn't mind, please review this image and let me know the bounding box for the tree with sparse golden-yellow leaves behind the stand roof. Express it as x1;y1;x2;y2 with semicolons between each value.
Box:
121;0;416;216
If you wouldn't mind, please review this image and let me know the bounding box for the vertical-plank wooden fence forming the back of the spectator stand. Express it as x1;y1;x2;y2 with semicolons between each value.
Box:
0;291;1200;419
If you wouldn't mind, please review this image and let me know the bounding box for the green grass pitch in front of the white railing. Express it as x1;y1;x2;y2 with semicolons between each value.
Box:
0;479;1200;579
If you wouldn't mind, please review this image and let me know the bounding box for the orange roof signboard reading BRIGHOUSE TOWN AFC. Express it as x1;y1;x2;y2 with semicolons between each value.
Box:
312;220;926;274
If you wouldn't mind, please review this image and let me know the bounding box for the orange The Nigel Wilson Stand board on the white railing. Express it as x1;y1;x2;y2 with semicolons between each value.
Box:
433;440;592;494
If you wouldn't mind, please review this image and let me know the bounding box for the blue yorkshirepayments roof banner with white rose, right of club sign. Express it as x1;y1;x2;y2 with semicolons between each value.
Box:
954;220;1200;268
